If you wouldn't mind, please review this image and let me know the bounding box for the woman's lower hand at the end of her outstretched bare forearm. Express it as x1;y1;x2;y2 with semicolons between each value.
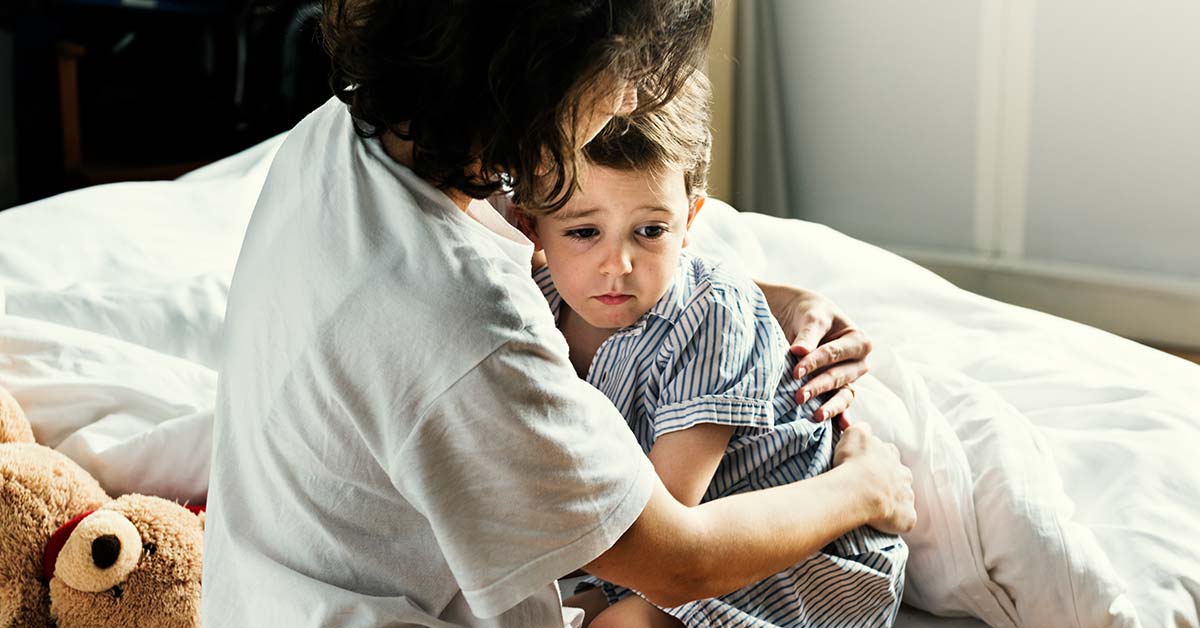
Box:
833;423;917;534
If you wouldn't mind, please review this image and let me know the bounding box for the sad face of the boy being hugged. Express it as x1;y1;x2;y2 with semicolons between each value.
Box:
532;162;702;329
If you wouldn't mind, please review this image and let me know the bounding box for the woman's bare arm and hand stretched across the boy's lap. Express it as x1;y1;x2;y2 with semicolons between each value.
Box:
584;425;917;606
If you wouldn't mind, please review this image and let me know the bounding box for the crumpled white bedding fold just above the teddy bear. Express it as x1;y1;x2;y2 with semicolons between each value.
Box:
0;316;217;502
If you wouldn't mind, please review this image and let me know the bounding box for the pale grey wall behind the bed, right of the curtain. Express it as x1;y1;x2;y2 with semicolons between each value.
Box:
758;0;1200;346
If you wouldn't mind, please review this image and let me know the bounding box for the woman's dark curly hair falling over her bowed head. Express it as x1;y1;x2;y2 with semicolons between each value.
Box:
322;0;713;213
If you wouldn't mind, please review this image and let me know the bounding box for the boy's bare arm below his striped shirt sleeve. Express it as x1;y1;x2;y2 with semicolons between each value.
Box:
649;423;733;506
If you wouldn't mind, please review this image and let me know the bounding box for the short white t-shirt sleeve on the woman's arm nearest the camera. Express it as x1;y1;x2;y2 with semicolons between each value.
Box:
389;328;654;617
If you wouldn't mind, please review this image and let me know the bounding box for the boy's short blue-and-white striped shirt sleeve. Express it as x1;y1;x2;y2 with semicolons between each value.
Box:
654;287;787;438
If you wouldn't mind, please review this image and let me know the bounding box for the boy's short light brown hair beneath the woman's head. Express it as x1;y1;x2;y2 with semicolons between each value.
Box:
583;70;713;201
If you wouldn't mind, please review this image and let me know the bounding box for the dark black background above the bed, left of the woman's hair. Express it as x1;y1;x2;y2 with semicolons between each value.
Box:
0;0;330;209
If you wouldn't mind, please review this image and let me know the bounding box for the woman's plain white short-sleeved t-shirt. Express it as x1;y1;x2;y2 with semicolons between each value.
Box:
203;98;654;628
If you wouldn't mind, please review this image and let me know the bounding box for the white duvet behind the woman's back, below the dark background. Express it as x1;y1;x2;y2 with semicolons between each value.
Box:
0;137;274;366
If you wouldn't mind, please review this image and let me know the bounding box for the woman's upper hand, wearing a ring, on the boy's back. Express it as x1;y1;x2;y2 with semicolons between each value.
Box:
758;282;871;429
